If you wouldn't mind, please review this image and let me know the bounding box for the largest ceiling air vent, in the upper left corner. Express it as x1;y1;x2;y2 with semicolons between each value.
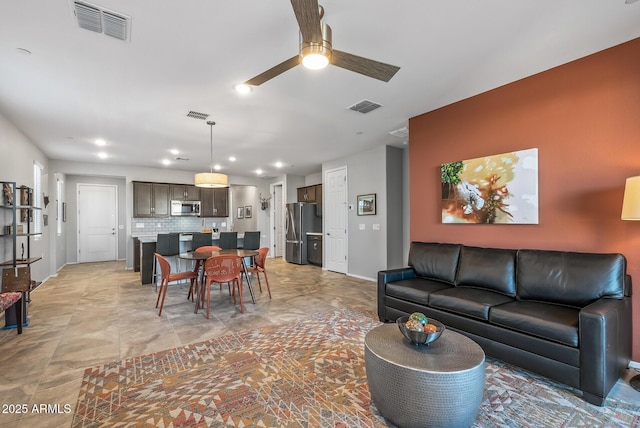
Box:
72;1;131;41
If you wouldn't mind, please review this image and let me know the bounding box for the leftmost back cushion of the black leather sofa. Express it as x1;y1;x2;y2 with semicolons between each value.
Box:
409;242;462;284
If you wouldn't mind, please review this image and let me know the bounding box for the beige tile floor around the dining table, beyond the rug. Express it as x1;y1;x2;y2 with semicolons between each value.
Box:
0;259;376;428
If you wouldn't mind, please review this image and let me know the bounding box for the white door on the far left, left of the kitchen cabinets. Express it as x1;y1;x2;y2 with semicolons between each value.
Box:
78;184;118;263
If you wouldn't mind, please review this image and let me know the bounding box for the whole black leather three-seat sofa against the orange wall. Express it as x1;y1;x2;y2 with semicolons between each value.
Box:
378;242;631;406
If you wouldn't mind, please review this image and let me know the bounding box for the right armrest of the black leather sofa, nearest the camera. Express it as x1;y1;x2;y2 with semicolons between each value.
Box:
579;297;631;406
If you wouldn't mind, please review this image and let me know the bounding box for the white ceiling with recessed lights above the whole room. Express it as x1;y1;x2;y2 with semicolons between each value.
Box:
0;0;640;177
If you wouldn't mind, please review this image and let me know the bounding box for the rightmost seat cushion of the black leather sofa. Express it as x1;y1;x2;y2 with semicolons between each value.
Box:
489;301;580;348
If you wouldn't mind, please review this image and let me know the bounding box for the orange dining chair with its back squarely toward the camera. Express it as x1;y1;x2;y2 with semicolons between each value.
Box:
196;254;244;319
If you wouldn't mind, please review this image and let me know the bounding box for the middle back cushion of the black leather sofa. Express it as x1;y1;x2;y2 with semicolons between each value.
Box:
456;247;517;296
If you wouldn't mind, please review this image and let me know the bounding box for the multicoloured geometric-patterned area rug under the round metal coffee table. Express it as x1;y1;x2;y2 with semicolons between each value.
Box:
72;309;640;428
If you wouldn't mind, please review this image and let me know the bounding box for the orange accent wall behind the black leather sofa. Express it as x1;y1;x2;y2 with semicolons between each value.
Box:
409;39;640;362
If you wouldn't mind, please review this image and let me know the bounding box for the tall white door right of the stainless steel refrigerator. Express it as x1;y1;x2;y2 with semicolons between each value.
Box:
322;166;348;274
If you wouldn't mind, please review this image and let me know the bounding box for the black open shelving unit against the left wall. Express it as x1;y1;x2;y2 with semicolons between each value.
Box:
0;181;42;329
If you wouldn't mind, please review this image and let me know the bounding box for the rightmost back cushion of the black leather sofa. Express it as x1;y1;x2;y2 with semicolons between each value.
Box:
516;250;626;308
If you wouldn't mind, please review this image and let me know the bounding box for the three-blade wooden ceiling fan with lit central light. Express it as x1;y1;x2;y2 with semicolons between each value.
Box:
245;0;400;86
